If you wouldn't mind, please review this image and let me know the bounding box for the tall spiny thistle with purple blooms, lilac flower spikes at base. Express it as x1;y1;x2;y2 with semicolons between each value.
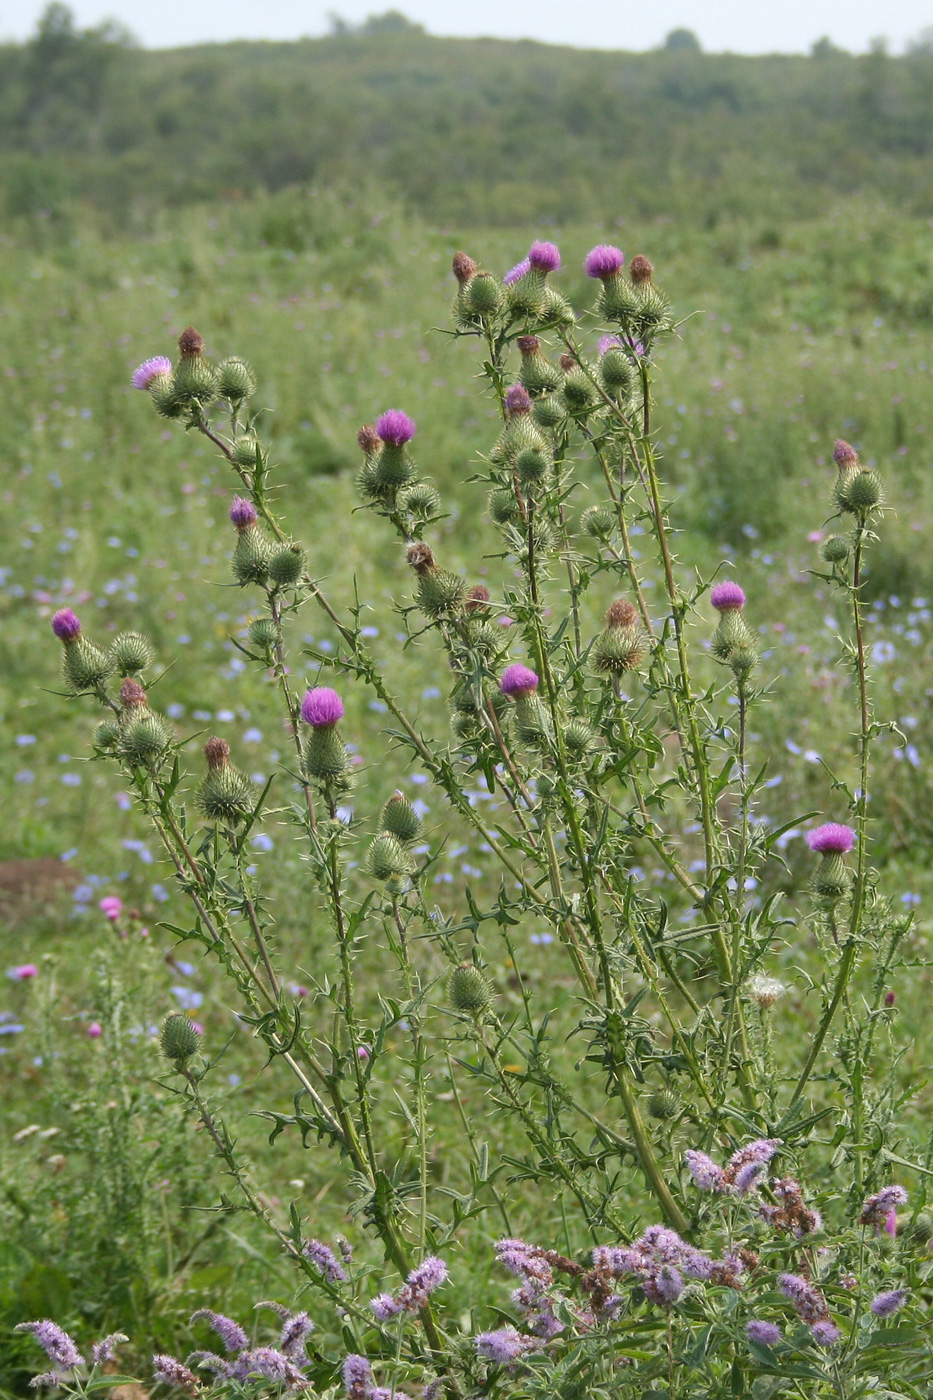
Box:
34;242;933;1400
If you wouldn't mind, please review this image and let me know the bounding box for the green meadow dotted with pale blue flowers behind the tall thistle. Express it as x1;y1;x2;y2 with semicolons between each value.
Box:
0;185;933;1393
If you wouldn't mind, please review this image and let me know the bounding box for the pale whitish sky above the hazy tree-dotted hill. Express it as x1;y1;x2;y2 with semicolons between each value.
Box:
0;0;933;53
